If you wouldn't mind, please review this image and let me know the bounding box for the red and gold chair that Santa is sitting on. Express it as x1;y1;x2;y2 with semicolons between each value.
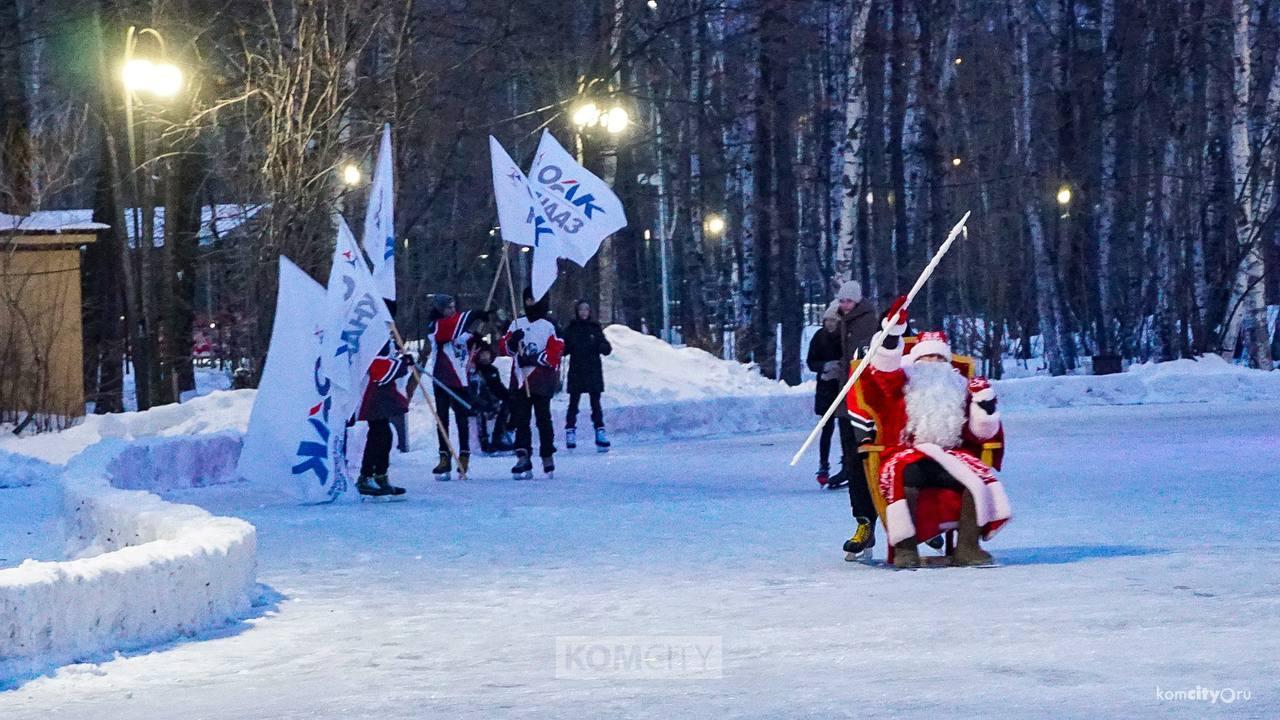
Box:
851;336;1005;565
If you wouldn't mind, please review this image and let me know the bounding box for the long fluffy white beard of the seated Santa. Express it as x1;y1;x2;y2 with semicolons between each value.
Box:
905;363;969;450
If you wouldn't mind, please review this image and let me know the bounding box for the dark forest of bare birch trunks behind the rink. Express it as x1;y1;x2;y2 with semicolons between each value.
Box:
0;0;1280;411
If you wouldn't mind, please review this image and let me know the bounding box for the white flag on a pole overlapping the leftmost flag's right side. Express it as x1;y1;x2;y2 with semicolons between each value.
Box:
321;215;392;409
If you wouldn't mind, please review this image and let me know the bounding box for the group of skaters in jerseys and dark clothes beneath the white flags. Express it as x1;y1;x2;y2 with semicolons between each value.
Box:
355;290;613;496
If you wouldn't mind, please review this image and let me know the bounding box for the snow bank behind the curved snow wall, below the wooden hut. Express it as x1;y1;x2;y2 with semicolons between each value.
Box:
0;389;256;465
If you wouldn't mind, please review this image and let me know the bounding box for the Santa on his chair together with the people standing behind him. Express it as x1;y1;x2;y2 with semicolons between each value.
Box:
806;281;1011;568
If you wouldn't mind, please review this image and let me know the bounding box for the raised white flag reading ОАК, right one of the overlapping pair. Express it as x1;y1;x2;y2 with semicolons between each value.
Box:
529;131;627;265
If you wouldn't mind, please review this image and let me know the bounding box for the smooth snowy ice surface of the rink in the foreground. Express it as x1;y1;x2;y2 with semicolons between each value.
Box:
0;400;1280;720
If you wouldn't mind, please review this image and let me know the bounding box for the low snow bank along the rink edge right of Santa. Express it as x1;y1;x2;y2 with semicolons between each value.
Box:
996;355;1280;410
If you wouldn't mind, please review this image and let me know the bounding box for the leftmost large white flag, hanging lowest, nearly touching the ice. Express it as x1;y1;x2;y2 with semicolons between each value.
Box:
237;258;348;502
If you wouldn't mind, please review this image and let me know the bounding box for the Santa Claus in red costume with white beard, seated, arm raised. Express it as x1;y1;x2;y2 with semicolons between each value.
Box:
850;300;1011;568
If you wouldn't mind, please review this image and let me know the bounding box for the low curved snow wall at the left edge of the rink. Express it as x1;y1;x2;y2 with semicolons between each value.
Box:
0;433;257;687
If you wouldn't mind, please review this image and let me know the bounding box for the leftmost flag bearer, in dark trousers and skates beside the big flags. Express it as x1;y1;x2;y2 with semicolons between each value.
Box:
356;342;413;495
